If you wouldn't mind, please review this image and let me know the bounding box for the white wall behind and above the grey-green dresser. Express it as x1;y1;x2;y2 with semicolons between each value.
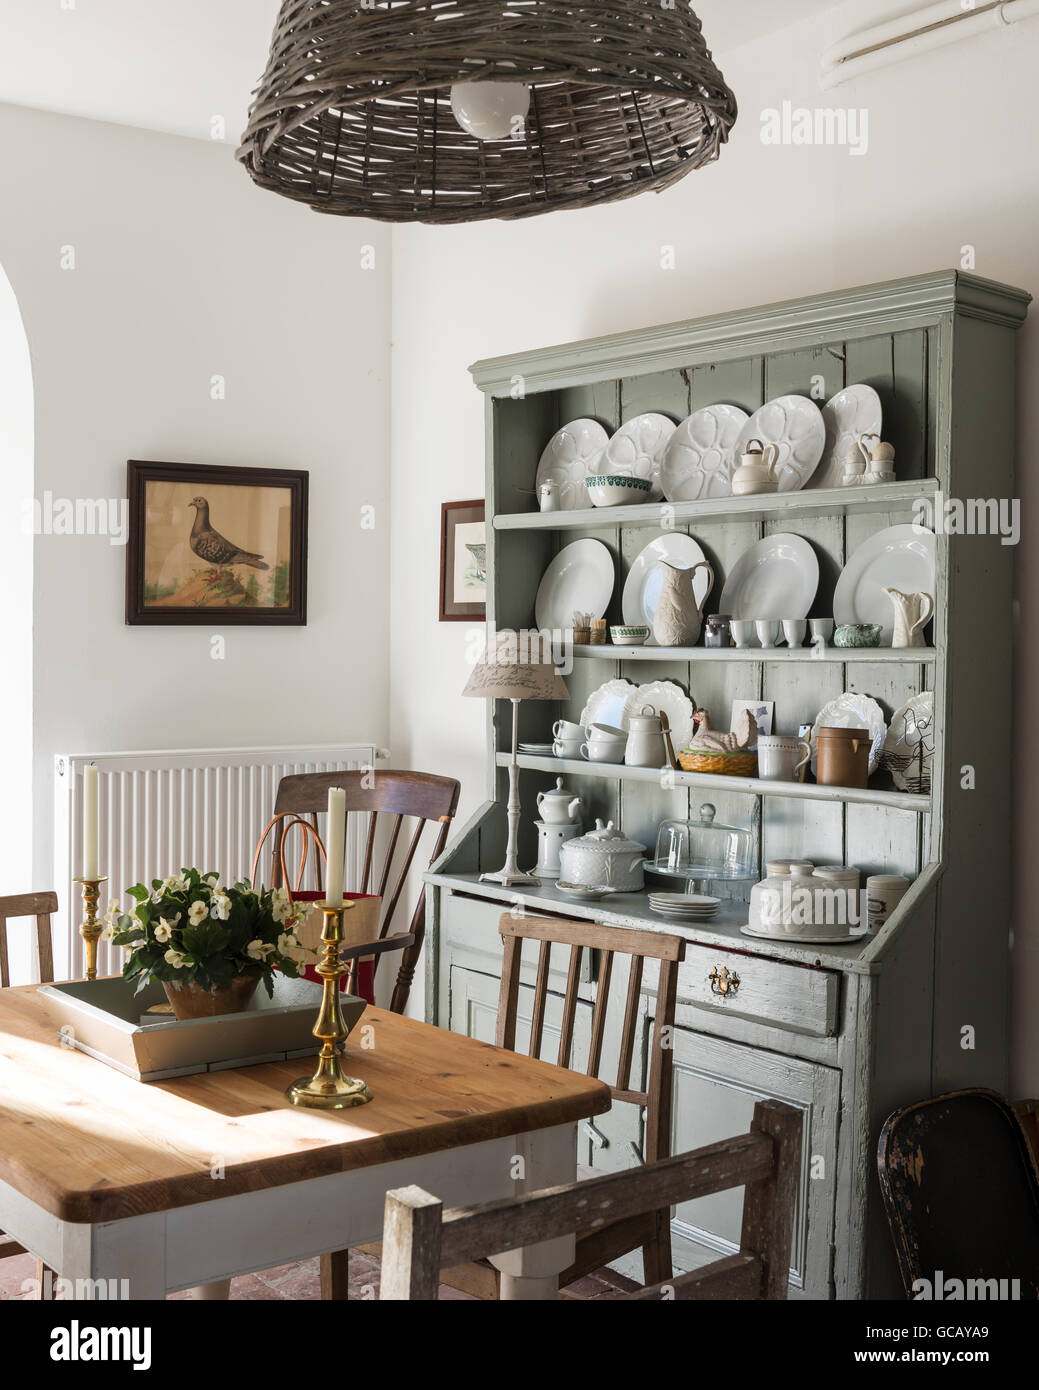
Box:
391;4;1039;1095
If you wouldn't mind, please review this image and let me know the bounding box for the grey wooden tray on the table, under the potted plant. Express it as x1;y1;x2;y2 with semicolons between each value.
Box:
39;976;364;1081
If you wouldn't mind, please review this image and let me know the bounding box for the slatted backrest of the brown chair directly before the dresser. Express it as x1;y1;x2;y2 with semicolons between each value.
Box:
495;912;686;1163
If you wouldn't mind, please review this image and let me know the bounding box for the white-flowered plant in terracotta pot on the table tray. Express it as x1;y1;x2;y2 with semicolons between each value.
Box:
104;869;313;1019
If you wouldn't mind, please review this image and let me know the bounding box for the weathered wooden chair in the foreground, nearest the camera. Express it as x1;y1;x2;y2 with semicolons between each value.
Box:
380;1101;803;1302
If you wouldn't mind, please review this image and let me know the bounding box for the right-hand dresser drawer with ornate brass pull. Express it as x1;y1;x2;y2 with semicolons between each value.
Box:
679;942;840;1037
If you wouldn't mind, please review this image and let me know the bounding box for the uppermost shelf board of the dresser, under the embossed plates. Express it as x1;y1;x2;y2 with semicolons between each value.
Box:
494;475;937;531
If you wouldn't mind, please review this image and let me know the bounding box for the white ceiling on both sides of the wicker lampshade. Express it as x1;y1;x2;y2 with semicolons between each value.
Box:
0;0;833;143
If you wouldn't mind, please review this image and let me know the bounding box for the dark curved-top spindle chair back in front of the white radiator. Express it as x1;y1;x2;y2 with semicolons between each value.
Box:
257;770;460;1013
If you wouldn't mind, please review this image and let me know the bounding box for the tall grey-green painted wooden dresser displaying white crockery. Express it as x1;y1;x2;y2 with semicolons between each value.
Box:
427;271;1029;1298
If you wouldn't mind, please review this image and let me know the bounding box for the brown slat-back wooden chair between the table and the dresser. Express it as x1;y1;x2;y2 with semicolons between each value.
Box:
433;912;686;1298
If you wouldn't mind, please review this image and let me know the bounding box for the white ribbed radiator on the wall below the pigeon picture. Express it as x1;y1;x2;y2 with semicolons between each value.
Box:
54;744;385;980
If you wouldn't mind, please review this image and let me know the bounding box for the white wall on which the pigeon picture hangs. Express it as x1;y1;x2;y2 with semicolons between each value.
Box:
0;106;389;922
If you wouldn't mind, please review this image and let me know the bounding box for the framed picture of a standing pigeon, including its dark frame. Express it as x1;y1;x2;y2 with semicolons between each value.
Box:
127;459;309;626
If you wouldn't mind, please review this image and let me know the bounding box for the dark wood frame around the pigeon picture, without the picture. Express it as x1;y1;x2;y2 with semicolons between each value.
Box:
127;459;310;627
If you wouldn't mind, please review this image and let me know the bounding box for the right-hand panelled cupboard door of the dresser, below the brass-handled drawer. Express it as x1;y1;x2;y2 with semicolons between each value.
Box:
672;1029;840;1298
